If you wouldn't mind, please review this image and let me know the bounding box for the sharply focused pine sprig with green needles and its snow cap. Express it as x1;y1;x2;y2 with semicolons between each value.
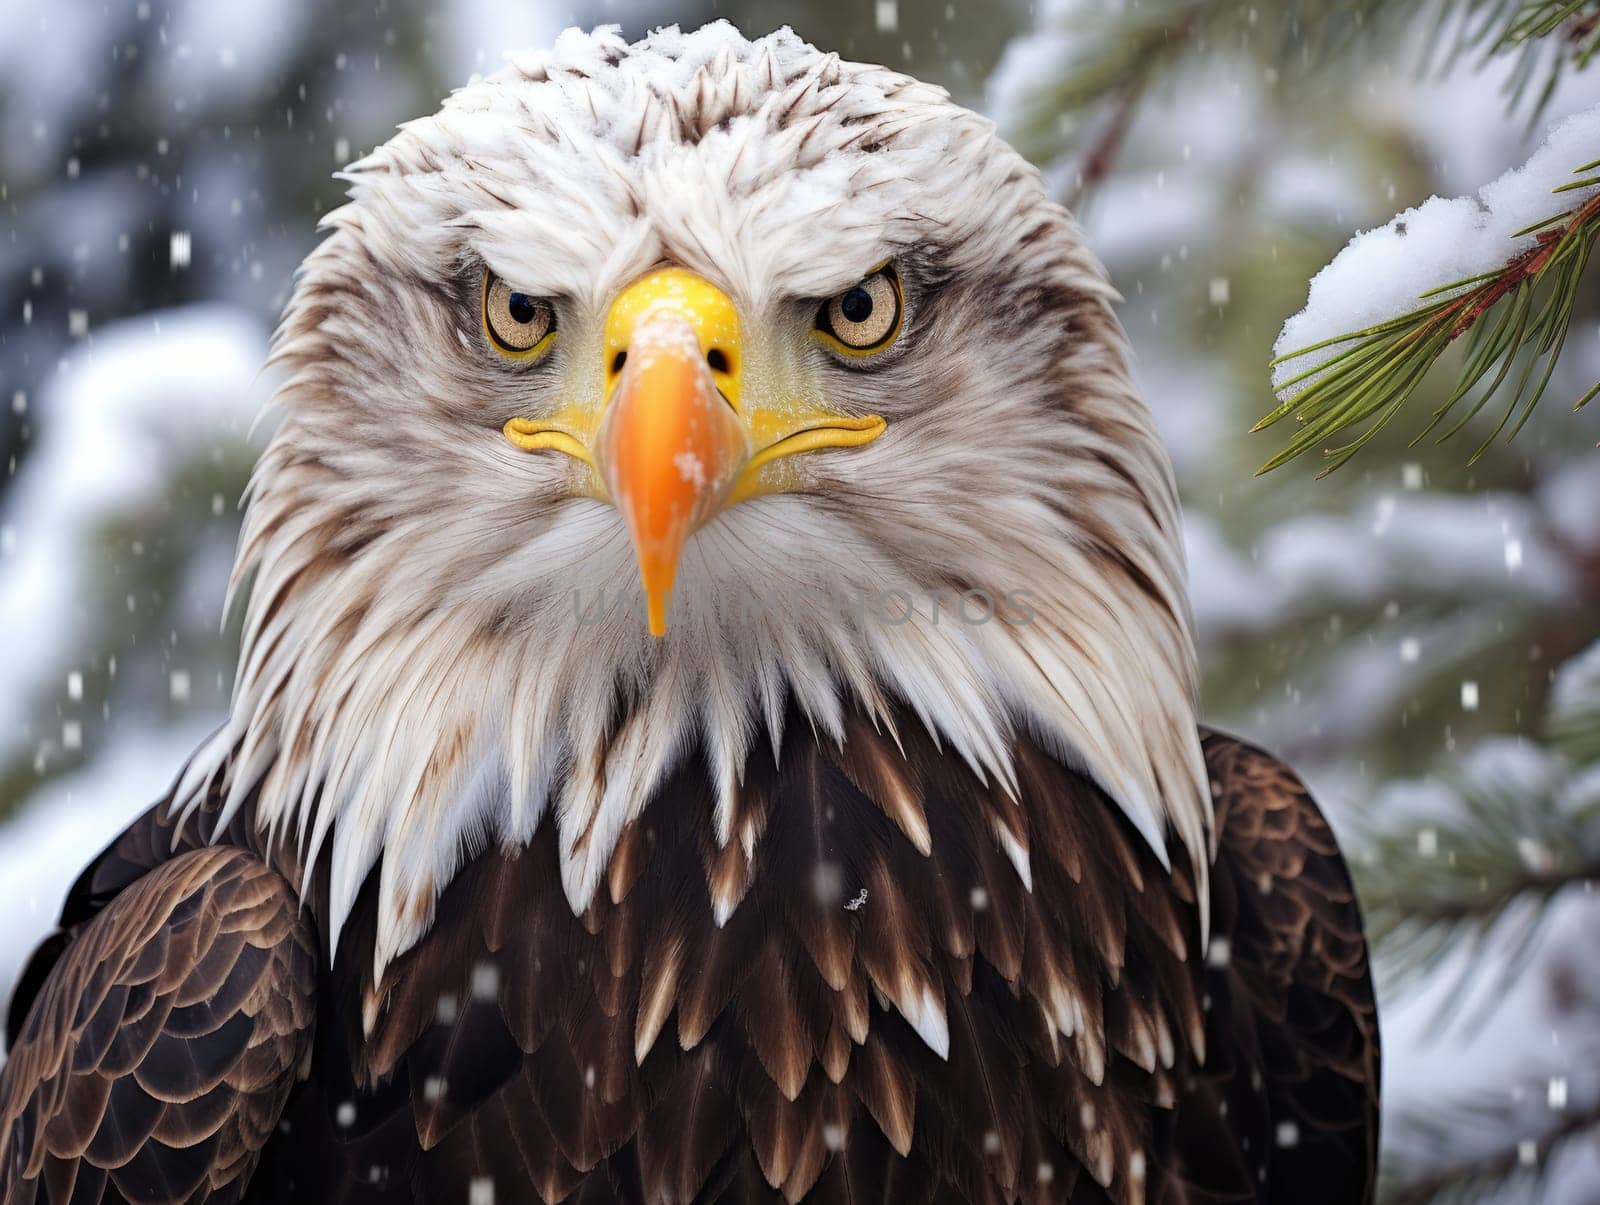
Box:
1254;106;1600;474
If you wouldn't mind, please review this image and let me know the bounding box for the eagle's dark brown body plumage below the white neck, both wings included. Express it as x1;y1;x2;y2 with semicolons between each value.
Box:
0;717;1378;1205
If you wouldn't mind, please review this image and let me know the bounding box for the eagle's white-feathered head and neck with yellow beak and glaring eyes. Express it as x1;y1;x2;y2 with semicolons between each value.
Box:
189;22;1210;967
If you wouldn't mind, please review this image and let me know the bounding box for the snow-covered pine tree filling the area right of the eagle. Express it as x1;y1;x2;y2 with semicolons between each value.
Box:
994;0;1600;1202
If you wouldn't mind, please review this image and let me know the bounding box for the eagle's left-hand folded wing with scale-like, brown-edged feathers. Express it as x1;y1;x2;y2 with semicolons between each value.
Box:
0;826;317;1205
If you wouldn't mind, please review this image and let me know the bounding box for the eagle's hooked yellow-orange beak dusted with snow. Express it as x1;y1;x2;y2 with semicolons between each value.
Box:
506;269;886;637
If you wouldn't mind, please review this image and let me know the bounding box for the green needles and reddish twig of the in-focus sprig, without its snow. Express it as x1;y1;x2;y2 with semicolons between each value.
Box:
1251;176;1600;477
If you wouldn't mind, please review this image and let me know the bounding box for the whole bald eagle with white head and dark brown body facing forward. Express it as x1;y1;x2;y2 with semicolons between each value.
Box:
0;24;1378;1205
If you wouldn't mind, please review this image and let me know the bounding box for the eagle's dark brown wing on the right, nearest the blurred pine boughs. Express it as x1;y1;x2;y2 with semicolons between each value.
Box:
1174;731;1379;1205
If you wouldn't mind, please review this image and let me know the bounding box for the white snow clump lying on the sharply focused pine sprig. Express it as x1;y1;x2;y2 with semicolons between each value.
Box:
1274;106;1600;395
